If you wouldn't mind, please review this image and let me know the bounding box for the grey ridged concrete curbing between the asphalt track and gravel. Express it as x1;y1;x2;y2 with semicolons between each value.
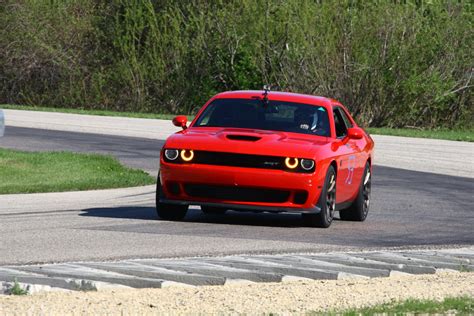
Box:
0;246;474;292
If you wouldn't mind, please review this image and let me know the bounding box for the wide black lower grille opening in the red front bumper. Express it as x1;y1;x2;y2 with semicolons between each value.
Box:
184;184;290;203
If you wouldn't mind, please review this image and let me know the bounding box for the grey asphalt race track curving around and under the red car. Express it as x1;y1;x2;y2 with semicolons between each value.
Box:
0;127;474;264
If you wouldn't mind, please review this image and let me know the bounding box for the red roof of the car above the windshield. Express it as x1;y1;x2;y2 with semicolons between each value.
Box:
214;90;339;106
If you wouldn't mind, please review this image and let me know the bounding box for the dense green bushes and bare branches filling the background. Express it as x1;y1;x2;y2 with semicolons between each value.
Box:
0;0;474;128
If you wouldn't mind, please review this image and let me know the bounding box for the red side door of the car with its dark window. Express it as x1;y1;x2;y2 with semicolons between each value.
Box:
333;106;362;203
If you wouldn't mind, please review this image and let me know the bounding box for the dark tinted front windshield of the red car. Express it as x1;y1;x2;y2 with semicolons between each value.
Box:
193;99;331;137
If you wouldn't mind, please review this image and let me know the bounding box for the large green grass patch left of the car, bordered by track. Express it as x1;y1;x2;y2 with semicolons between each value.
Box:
0;149;155;194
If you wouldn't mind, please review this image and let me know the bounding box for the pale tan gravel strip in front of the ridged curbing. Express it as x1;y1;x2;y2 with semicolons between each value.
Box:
0;272;474;315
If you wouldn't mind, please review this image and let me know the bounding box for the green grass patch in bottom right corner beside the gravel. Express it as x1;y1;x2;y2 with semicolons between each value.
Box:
316;296;474;316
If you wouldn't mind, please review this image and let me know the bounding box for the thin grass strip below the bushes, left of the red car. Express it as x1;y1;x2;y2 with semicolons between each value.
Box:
0;104;185;120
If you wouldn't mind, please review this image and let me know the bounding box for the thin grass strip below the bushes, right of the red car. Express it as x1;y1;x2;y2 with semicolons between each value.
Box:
367;127;474;142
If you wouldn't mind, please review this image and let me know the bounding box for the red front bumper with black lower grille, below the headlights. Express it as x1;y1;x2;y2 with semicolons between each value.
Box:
160;160;324;213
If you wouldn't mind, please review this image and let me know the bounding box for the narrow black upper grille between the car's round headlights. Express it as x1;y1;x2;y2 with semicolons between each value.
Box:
193;151;286;170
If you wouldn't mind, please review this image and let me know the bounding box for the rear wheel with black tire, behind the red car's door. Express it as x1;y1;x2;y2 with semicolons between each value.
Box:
339;162;372;222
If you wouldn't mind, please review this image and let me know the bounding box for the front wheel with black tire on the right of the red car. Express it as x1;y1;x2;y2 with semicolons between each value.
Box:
303;166;336;228
